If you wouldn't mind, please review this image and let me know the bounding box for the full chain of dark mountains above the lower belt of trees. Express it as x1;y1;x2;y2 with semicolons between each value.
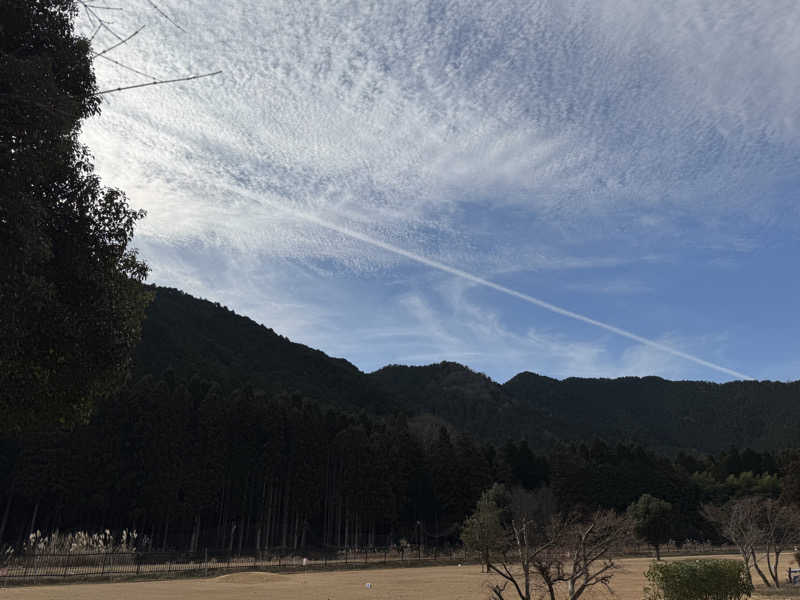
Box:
139;288;800;454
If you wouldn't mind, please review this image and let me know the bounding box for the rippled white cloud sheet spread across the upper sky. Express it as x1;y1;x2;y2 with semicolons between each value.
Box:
81;0;800;264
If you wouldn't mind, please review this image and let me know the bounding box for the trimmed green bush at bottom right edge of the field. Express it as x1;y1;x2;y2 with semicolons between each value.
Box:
645;559;753;600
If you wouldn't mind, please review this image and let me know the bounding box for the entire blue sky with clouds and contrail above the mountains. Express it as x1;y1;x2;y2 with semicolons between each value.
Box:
77;0;800;382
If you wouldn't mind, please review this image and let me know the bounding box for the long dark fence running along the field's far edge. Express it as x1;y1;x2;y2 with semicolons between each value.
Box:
0;547;474;585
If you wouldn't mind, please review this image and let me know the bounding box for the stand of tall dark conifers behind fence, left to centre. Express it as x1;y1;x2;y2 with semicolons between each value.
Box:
0;372;528;552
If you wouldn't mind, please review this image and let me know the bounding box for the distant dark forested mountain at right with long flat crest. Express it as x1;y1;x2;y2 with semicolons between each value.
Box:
502;372;800;452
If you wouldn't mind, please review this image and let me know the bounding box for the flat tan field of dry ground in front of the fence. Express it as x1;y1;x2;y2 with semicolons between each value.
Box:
0;556;800;600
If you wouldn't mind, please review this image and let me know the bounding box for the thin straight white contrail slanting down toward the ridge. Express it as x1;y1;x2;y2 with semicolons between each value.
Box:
223;184;754;379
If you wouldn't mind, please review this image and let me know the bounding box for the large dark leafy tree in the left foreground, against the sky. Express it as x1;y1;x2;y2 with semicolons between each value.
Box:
0;0;148;432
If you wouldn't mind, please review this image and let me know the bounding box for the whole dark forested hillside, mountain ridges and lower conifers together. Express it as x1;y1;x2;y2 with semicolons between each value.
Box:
0;288;800;554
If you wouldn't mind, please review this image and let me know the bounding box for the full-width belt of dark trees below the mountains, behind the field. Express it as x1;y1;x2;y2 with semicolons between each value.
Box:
0;371;800;552
